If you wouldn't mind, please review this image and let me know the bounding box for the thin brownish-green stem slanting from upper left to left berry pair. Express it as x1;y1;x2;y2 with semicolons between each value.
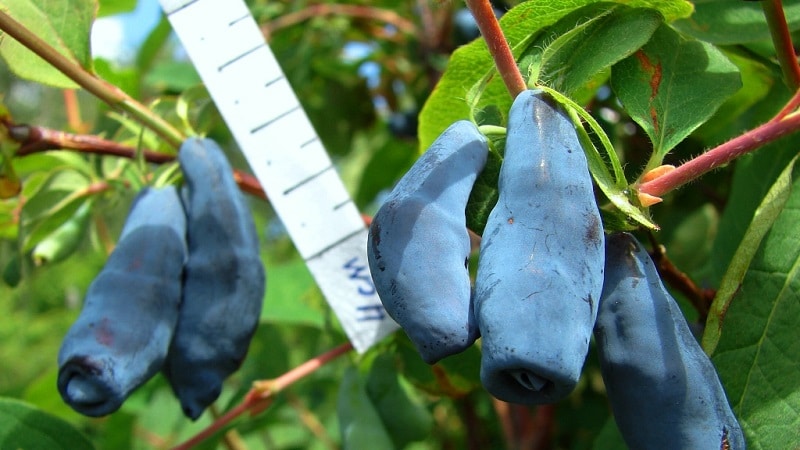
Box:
0;11;184;148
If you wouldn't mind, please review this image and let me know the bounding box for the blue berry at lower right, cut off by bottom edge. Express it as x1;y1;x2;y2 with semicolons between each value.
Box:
594;233;745;450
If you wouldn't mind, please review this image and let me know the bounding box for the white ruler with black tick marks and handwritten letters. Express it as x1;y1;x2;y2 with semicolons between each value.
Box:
159;0;397;352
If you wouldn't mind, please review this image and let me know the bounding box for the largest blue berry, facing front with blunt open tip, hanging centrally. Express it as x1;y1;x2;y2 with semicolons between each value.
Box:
475;90;604;404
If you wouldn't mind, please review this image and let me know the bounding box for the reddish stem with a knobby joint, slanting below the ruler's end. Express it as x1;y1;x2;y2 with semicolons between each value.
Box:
173;342;353;450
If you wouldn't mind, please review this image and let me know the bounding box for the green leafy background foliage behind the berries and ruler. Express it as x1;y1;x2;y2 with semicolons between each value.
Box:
0;0;800;449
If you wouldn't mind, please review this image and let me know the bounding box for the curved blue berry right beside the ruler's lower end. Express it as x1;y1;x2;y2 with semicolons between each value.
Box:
367;121;489;364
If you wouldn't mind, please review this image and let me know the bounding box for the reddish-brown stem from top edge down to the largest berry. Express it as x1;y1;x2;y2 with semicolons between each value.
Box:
467;0;527;98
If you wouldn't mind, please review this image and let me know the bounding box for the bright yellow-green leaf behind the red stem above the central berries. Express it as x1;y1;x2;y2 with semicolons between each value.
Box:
419;0;692;152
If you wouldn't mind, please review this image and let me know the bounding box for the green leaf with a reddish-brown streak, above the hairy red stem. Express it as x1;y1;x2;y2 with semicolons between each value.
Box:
611;25;741;167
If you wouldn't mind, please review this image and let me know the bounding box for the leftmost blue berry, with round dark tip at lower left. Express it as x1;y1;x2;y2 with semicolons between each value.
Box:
58;187;187;416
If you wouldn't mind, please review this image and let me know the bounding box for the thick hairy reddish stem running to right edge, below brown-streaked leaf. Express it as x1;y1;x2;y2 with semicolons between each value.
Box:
638;110;800;197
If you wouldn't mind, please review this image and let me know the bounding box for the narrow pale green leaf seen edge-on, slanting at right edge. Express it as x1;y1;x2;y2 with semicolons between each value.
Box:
703;156;797;355
